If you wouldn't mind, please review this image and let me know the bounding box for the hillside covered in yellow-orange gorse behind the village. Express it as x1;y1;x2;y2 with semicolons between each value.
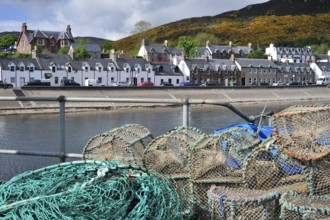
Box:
113;0;330;51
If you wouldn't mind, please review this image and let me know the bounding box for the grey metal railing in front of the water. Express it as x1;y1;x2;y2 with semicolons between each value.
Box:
0;96;272;162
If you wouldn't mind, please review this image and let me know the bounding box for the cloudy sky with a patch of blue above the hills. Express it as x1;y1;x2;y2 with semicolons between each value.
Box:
0;0;268;40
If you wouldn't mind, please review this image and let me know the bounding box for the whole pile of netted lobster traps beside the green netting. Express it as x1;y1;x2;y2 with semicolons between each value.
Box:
78;105;330;219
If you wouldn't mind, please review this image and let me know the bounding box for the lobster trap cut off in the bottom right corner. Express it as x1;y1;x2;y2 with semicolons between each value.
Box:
280;191;330;220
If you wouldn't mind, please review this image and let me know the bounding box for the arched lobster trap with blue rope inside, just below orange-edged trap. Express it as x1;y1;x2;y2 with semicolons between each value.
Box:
243;139;307;192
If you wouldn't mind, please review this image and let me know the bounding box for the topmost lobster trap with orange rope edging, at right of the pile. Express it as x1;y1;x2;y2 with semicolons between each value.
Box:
273;105;330;160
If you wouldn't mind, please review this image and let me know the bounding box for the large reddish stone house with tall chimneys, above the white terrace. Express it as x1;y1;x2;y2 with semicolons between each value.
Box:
16;23;74;53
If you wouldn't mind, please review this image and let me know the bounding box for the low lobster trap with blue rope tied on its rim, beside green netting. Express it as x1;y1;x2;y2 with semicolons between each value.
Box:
207;186;279;220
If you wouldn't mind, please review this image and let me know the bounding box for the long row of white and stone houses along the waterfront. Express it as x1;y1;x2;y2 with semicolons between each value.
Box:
0;54;330;87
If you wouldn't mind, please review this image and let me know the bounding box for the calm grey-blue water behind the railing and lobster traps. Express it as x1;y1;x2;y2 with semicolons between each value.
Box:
0;100;324;180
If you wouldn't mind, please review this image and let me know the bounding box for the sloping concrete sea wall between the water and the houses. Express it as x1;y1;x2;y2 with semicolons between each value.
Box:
0;86;330;114
